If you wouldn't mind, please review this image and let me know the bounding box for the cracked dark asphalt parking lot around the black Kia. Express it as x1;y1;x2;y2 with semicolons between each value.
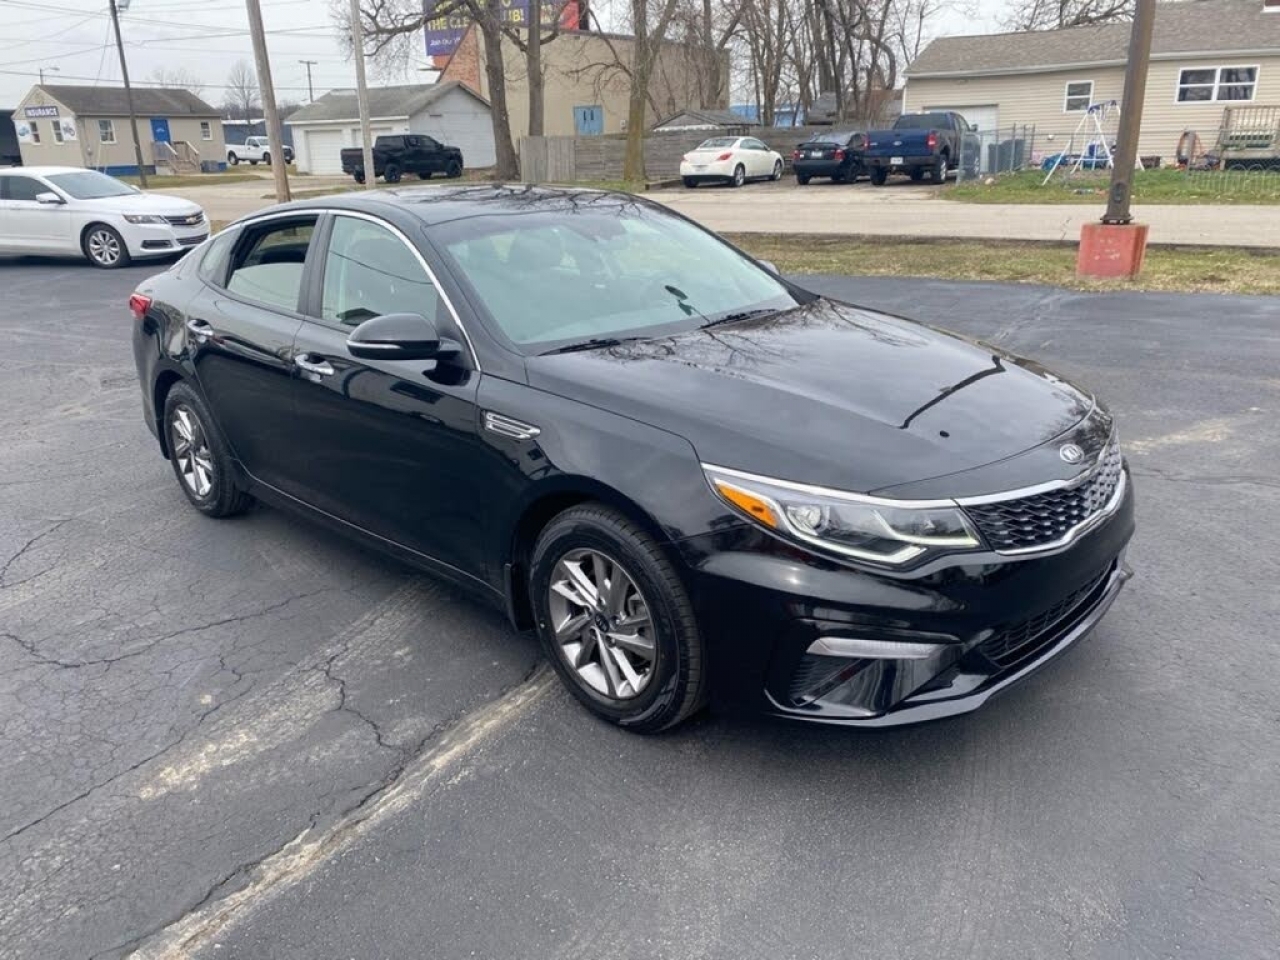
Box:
0;262;1280;960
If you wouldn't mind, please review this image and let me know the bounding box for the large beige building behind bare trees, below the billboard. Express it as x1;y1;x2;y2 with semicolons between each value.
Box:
440;26;728;141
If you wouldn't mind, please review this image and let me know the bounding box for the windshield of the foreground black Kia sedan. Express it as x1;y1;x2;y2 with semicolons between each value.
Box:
431;197;799;353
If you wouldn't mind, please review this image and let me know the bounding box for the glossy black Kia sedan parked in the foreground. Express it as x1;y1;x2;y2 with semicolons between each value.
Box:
131;186;1134;731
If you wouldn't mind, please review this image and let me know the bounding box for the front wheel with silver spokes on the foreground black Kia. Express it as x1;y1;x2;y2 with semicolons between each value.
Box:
530;504;705;733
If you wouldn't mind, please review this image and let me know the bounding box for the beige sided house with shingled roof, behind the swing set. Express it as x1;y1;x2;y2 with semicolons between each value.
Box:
902;0;1280;163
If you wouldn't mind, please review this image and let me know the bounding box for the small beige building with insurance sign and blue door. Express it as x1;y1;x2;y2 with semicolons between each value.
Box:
13;83;227;175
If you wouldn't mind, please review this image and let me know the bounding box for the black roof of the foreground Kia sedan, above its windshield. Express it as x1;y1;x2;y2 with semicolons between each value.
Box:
242;183;652;225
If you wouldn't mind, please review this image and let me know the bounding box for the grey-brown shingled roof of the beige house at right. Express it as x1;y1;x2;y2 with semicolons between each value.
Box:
906;0;1280;79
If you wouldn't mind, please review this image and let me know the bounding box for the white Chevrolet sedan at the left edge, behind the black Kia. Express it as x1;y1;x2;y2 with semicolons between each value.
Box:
0;166;209;269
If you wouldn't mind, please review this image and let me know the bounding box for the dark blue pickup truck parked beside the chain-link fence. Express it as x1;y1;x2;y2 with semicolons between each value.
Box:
863;113;982;187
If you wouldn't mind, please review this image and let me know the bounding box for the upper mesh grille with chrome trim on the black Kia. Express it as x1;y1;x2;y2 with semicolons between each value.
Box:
965;442;1124;553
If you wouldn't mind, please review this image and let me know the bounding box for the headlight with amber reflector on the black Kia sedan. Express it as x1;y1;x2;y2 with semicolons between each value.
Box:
703;465;982;566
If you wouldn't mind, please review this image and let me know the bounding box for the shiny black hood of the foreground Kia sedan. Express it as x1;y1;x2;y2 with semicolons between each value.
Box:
527;300;1094;493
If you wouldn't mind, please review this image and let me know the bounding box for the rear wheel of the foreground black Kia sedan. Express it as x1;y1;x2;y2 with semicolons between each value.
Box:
164;383;253;517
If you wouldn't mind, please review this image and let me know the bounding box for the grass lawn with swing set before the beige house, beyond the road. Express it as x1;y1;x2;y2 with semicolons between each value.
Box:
940;170;1280;205
